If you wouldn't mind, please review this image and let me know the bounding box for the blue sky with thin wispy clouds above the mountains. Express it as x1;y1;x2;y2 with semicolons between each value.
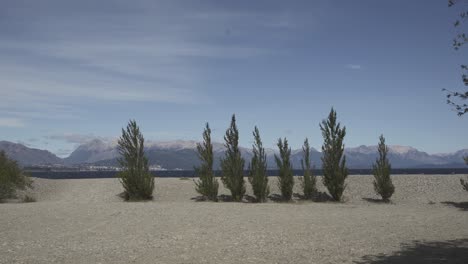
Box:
0;0;468;157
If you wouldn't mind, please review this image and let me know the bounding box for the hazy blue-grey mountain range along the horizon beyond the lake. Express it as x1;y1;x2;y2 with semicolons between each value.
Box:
0;139;468;170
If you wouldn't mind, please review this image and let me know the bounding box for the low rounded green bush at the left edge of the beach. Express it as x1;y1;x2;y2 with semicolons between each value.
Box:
0;151;32;201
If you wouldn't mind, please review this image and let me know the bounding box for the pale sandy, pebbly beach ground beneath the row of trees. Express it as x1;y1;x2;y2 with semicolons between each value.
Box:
0;175;468;263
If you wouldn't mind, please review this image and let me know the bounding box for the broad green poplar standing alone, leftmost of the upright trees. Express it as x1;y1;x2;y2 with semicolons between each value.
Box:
118;120;154;200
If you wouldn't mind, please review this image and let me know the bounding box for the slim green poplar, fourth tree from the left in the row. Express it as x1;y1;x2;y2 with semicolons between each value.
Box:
249;127;270;202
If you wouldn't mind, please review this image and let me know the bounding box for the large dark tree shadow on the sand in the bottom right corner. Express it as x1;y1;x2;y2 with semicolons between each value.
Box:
354;239;468;264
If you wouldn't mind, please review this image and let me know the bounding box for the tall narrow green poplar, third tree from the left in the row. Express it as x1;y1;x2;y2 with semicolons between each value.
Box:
221;115;245;202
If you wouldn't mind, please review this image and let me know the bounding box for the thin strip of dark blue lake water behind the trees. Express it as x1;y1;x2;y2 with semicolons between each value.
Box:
27;168;468;179
